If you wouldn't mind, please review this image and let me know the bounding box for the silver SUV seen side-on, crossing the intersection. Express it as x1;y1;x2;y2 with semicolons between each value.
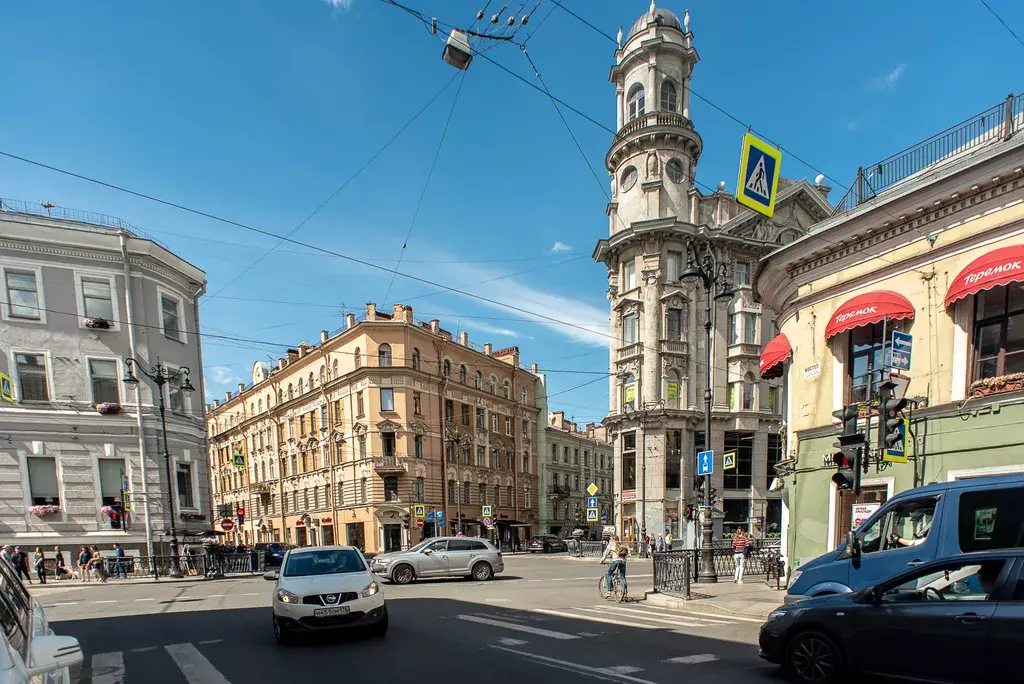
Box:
370;537;505;585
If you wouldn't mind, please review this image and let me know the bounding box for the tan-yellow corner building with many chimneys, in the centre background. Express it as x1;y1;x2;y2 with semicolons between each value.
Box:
201;304;544;552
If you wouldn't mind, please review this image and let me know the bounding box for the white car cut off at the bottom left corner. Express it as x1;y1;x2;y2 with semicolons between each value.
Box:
0;562;83;684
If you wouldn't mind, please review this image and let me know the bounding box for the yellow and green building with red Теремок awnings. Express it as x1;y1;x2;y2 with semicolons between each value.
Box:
756;97;1024;567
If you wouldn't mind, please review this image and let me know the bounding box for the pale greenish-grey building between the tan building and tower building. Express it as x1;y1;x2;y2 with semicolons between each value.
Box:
538;411;613;537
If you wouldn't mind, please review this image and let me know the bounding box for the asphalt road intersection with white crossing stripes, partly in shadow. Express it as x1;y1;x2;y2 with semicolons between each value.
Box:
32;556;779;684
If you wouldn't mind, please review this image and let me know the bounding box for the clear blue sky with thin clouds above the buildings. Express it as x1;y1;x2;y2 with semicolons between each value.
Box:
0;0;1024;421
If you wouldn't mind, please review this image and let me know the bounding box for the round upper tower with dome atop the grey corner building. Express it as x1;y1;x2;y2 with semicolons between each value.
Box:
605;2;702;233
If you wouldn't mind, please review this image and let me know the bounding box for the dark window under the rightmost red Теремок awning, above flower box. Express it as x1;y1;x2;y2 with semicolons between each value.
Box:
972;283;1024;380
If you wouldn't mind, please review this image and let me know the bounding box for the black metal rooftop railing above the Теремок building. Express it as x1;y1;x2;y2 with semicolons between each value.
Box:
833;95;1024;216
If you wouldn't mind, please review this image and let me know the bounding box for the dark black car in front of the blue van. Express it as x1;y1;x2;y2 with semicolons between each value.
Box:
759;548;1024;684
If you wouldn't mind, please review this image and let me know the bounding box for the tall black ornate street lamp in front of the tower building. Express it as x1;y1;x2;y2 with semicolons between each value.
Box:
679;242;735;583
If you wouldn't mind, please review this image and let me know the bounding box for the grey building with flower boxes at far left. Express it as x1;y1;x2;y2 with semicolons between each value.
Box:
0;200;212;553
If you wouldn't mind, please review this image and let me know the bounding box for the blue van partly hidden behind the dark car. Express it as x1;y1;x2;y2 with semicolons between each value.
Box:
785;475;1024;603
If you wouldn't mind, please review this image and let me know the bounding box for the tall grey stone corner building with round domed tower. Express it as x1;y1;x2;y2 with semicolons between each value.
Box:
594;3;833;547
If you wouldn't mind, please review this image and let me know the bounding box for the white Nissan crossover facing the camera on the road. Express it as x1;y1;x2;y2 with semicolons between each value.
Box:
263;546;387;644
